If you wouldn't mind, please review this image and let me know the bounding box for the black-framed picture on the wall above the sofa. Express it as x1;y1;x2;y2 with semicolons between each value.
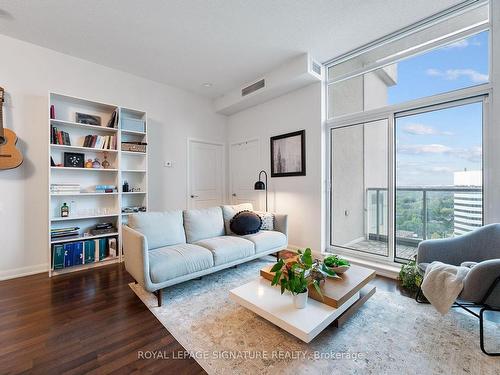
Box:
271;130;306;177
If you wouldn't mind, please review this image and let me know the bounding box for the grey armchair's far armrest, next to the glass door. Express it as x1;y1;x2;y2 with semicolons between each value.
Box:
417;235;475;266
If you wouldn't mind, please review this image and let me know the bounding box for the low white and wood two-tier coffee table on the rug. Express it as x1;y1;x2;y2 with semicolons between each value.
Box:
229;265;375;343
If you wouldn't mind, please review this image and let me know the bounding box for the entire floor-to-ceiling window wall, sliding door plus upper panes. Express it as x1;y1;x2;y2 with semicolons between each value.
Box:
327;2;490;262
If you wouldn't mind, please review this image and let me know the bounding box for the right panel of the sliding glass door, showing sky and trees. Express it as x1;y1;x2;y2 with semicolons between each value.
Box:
394;99;483;260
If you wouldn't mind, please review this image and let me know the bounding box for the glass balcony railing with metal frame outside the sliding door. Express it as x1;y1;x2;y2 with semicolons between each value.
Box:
366;186;483;255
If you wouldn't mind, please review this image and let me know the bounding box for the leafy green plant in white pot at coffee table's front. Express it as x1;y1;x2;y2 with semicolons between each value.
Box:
271;249;323;309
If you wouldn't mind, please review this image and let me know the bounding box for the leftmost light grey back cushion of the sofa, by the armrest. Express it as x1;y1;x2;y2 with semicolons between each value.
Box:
128;211;186;250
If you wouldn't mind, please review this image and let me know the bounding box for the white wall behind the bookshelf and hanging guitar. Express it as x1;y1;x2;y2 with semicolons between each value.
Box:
0;35;226;279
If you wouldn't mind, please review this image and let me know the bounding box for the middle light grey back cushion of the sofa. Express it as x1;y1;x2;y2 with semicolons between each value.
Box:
184;207;224;243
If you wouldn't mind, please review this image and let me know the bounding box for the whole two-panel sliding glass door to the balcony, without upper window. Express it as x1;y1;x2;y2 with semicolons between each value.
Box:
329;96;485;262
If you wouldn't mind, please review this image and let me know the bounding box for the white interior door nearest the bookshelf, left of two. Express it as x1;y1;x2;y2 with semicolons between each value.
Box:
188;140;224;208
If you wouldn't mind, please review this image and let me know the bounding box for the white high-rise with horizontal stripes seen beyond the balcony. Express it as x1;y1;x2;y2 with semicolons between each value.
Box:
453;170;483;236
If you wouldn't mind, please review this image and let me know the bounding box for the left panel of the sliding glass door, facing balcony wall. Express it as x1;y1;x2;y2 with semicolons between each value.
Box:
330;119;389;256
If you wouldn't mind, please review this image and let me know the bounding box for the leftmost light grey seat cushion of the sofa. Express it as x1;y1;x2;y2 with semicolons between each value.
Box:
149;244;214;283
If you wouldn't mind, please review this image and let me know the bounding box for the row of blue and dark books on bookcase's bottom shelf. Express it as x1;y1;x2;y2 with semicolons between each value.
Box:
52;237;118;270
